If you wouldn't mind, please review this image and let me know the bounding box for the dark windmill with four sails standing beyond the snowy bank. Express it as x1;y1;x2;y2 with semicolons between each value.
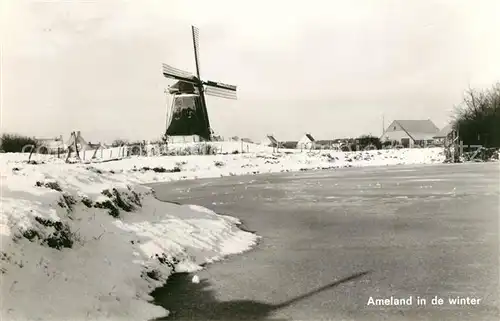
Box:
163;26;236;140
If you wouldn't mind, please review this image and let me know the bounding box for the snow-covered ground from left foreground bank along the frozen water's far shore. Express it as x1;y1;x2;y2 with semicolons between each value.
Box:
0;146;444;321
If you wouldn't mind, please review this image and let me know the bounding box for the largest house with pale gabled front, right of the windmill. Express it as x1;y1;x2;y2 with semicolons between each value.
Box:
380;119;439;148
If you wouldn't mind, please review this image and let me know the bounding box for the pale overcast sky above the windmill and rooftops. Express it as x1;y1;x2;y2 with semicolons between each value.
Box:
0;0;500;141
